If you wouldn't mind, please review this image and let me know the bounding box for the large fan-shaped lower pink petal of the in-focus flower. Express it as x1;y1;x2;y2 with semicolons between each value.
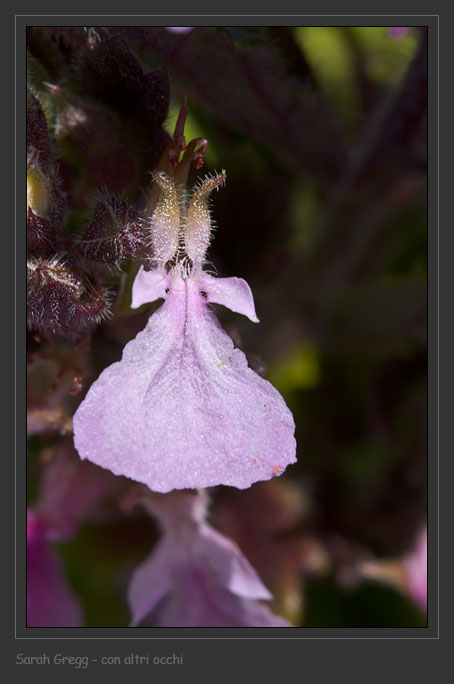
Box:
74;277;296;492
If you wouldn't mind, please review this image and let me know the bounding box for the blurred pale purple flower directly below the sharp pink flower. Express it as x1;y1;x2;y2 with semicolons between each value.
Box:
128;492;292;627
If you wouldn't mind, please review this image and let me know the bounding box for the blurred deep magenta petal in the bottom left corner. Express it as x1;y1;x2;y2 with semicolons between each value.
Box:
27;512;83;627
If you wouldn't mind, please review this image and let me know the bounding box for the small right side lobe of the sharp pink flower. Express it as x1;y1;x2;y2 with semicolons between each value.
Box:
199;273;259;323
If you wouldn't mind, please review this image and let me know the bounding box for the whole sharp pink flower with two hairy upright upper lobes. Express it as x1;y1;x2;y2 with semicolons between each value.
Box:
74;172;296;492
